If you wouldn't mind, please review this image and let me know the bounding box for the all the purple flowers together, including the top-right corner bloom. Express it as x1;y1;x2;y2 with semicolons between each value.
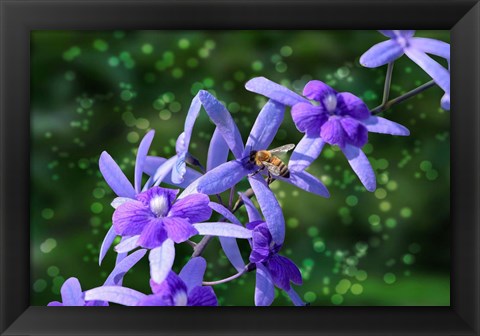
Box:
50;30;450;306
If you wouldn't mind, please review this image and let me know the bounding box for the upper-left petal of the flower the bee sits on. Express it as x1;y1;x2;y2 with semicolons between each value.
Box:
199;90;244;158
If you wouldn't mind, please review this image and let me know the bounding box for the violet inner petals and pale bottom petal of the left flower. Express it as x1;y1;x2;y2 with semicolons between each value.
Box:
112;187;212;283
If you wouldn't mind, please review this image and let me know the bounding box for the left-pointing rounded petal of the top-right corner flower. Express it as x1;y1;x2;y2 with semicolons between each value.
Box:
360;40;403;68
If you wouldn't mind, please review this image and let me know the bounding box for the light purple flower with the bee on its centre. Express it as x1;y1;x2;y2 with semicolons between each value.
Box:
180;91;329;205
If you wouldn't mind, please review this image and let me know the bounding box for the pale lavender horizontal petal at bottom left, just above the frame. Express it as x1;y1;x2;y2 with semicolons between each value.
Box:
85;286;147;306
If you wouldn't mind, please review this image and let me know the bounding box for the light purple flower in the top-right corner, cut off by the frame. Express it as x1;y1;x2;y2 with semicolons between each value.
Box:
360;30;450;109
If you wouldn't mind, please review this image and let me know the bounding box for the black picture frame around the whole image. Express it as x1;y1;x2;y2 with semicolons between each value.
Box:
0;0;480;335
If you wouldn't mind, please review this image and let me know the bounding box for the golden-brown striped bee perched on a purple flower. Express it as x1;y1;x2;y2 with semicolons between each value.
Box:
250;144;295;180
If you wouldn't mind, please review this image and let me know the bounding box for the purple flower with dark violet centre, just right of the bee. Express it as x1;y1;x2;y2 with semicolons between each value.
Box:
245;77;410;191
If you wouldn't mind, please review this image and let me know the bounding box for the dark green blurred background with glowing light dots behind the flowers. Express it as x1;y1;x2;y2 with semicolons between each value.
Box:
30;31;450;306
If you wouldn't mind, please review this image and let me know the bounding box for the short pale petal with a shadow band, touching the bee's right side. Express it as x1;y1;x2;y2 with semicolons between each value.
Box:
288;135;325;171
